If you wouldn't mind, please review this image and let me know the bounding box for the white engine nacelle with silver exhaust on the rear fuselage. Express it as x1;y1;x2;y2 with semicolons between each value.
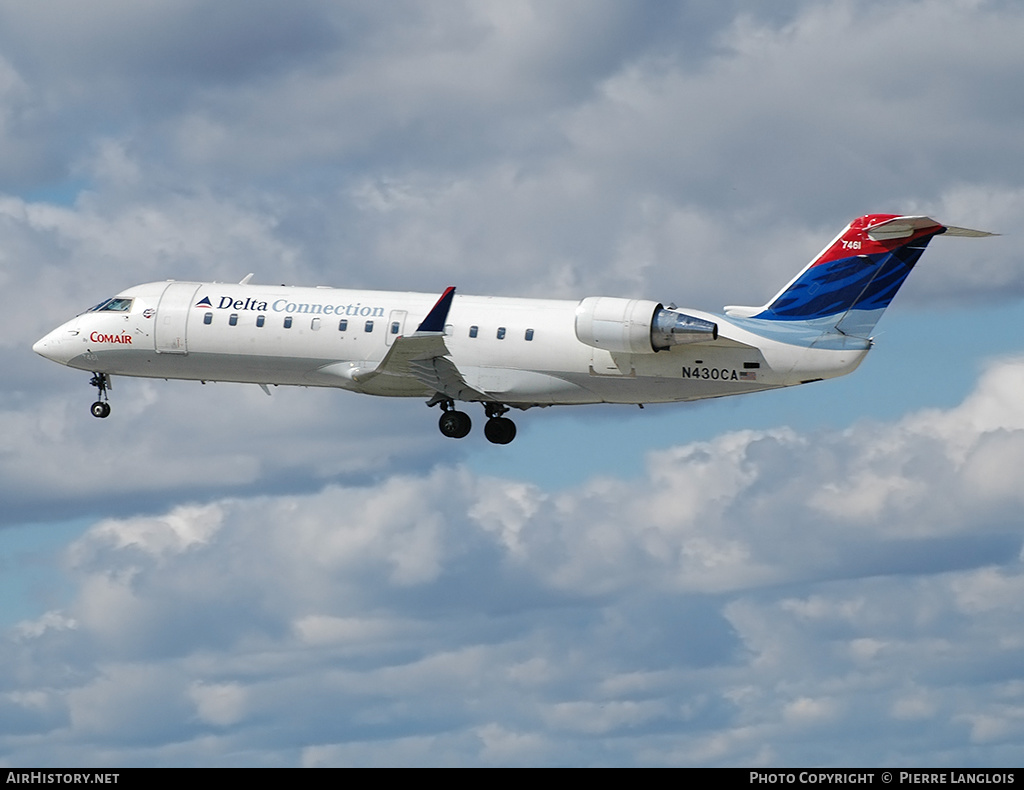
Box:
575;296;718;354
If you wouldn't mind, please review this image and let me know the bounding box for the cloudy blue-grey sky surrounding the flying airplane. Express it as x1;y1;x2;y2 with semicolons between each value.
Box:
0;0;1024;766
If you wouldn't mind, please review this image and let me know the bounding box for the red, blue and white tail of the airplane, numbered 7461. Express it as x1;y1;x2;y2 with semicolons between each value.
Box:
725;214;993;344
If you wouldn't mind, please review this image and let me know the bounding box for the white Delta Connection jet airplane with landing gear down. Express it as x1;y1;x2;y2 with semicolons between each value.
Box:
33;214;994;445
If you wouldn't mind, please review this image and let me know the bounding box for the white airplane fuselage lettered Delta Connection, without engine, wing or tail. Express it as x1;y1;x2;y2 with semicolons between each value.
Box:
34;281;869;408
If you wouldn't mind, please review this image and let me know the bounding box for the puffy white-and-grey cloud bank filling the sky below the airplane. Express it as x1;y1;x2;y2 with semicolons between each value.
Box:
0;359;1024;764
